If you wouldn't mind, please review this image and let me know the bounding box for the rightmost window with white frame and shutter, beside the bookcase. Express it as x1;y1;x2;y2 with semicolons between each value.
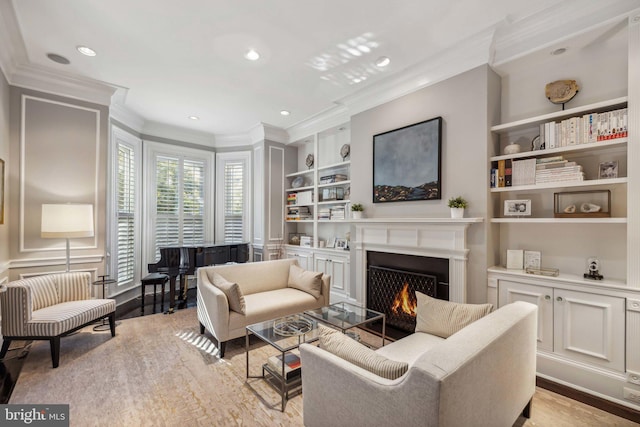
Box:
216;152;251;242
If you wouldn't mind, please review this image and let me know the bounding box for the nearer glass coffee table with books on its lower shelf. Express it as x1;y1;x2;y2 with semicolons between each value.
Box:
245;313;319;412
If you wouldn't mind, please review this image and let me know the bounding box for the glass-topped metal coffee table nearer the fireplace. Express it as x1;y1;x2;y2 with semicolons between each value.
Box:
304;302;386;347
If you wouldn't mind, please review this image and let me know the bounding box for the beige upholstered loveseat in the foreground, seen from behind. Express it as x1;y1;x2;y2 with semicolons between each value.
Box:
300;302;537;427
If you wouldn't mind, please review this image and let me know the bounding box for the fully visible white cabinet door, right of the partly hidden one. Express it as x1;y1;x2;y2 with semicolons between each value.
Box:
554;289;625;372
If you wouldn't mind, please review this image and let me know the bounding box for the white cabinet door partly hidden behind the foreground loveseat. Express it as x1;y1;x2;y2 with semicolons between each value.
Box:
498;280;553;351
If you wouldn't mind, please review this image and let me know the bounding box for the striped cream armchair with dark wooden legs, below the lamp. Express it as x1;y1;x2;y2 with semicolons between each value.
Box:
0;272;116;368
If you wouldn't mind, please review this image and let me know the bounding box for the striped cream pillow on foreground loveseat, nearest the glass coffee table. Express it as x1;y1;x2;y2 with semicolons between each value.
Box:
318;325;409;380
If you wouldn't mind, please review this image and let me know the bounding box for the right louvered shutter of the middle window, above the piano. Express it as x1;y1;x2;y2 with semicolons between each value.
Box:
182;160;204;245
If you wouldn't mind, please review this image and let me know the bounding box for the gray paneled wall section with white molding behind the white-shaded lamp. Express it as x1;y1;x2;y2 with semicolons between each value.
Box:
8;87;109;280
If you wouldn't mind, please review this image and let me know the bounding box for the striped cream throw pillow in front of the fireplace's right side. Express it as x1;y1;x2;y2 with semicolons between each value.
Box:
416;292;493;338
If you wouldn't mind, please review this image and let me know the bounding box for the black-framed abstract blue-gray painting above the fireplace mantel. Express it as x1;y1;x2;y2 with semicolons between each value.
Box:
373;117;442;203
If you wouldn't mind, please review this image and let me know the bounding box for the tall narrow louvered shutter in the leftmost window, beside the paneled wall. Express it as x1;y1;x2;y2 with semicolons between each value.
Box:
117;144;136;283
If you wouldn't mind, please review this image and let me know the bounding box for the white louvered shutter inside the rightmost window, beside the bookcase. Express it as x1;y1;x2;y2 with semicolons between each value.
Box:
224;161;245;242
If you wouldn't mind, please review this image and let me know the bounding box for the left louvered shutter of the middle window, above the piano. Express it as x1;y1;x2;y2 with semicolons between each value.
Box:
155;156;180;258
